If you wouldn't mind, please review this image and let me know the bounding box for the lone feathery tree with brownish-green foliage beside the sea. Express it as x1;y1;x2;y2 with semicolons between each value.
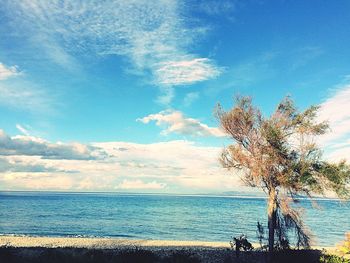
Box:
216;97;350;255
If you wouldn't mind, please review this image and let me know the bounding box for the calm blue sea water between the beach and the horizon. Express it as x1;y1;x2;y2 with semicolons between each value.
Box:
0;192;350;246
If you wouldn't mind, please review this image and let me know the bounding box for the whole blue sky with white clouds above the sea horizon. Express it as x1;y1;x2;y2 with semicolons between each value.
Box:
0;0;350;193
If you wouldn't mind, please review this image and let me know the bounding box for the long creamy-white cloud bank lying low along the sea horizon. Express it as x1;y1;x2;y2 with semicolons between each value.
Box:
0;129;240;193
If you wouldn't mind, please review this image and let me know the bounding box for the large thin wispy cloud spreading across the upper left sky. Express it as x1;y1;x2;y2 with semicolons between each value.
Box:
8;0;221;102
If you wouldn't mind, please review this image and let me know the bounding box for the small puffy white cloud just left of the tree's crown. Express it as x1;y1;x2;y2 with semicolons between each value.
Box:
138;110;225;137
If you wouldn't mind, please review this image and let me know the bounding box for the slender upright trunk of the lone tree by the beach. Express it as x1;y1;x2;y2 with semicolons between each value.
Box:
267;188;277;260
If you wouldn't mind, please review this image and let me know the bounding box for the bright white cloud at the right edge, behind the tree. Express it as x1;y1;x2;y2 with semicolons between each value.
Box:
318;84;350;160
